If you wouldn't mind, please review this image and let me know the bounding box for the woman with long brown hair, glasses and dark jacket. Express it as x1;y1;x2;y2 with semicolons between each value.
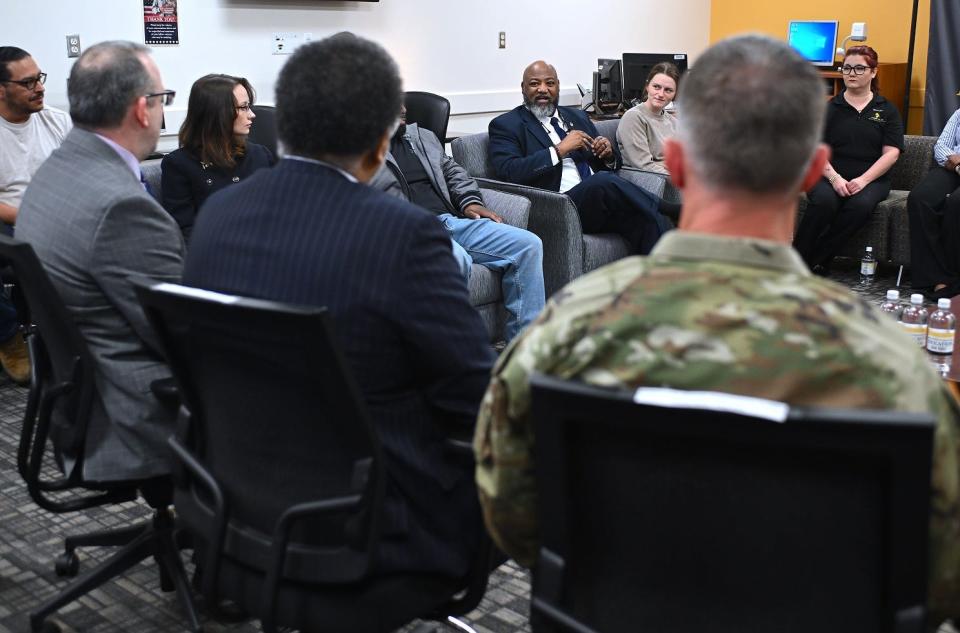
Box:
160;75;275;241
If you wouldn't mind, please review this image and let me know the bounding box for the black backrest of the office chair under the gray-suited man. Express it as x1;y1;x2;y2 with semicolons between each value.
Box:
0;235;95;482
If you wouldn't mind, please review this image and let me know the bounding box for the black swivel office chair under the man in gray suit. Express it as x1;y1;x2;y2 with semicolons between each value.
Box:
0;236;199;631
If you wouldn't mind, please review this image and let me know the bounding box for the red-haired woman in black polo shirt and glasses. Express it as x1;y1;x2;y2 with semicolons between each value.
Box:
793;46;903;273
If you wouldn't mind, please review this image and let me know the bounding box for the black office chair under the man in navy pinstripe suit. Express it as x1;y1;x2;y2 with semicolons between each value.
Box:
138;284;490;633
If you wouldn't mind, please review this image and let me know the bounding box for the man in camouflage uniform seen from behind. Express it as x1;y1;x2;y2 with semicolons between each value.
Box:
474;36;960;618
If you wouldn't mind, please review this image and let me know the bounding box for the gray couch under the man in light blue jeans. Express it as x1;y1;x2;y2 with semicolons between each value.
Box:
141;160;530;342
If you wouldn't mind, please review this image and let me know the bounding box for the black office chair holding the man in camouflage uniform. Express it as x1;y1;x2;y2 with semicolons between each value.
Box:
531;376;934;633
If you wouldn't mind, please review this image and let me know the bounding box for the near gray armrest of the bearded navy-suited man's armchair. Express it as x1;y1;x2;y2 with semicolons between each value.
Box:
476;178;583;297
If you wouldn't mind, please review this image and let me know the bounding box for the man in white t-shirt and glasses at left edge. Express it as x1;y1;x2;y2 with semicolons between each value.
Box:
0;46;72;384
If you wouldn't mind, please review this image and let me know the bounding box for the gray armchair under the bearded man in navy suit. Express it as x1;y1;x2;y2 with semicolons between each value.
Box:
452;120;667;297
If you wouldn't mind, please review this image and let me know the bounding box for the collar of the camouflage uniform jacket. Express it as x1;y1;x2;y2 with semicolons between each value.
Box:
650;231;810;275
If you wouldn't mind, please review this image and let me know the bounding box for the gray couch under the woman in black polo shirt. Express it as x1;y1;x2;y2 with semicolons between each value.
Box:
798;134;937;265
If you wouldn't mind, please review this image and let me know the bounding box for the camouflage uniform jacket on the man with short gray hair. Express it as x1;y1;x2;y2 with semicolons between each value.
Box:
474;231;960;614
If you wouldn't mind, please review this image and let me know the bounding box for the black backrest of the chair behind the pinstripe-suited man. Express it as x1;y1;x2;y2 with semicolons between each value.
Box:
138;284;383;582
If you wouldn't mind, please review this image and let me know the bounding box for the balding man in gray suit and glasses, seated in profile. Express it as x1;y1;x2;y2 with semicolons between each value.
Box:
16;42;184;481
